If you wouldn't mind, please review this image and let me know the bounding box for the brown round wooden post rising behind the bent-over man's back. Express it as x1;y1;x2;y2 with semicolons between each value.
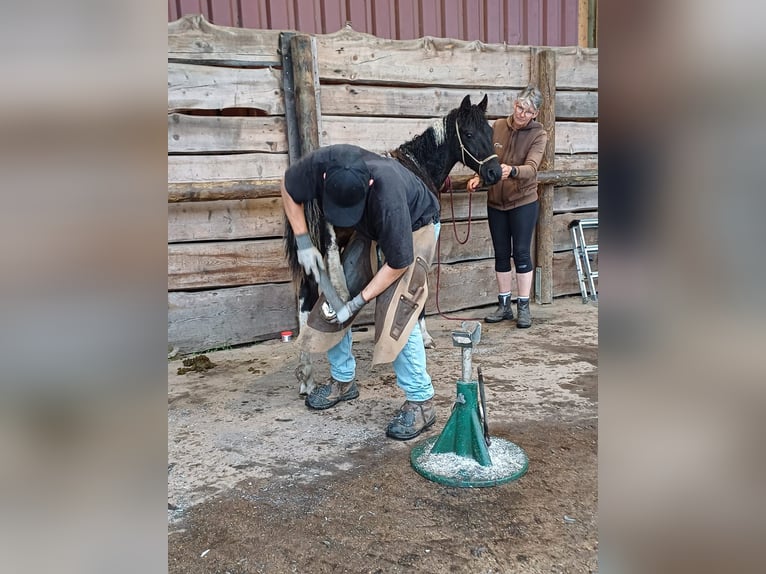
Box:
290;34;322;161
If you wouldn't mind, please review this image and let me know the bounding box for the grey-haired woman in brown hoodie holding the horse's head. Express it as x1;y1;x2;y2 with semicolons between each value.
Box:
467;85;548;329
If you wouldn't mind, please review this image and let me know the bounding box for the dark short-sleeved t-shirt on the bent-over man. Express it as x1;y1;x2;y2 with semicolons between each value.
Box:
285;144;439;269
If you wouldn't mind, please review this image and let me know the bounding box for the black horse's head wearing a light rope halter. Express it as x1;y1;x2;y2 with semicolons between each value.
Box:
456;94;502;185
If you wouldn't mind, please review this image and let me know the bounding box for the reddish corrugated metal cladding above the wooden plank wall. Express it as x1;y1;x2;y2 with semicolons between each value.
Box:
168;0;579;46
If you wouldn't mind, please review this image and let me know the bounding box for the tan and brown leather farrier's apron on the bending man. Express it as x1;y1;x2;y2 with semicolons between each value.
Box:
298;223;436;365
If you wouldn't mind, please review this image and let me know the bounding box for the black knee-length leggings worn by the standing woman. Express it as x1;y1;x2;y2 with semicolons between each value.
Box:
487;201;539;273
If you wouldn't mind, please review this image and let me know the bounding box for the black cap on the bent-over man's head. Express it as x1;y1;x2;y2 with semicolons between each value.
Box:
322;146;371;227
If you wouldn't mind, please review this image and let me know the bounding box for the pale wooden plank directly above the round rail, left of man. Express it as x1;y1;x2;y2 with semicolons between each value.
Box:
168;153;288;184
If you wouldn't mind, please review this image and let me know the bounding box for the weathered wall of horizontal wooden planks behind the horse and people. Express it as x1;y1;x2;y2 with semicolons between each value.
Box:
168;16;598;352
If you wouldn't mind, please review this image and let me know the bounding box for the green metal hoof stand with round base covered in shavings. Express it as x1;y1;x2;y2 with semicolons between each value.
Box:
410;321;529;488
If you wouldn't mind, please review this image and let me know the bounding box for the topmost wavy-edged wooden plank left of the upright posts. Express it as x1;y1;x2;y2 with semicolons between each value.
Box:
168;14;281;66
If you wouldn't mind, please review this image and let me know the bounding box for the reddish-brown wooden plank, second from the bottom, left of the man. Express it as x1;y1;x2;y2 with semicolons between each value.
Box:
168;239;291;291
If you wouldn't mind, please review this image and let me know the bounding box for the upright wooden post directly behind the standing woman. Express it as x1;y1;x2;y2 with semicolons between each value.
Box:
530;48;556;305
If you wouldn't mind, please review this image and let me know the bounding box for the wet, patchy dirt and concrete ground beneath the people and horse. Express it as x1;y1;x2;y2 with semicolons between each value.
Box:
168;297;598;574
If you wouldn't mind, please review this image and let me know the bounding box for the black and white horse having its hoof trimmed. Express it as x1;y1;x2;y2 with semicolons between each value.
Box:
284;95;502;395
